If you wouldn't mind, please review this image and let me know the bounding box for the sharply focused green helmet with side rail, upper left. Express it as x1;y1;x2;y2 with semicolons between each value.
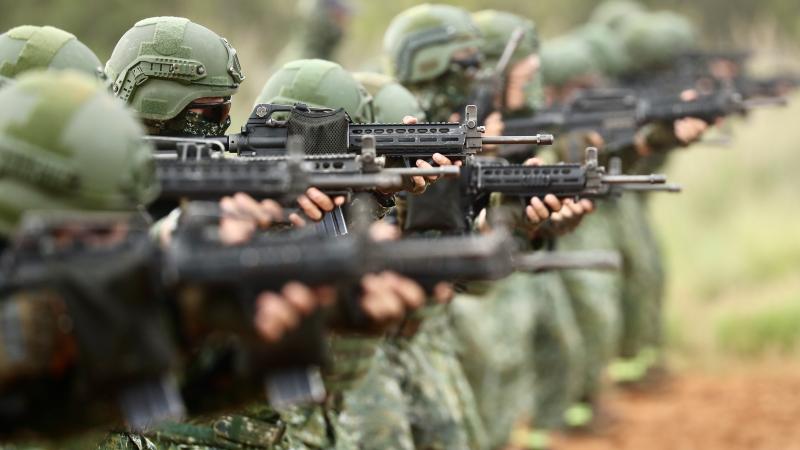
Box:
105;17;244;125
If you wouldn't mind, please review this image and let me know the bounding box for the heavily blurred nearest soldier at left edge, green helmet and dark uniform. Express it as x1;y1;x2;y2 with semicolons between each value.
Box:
0;72;158;448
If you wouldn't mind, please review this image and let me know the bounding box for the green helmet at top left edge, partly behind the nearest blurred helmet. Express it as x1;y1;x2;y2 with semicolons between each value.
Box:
0;25;103;78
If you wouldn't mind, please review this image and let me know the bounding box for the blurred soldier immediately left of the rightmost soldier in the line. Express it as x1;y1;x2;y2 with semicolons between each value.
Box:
542;30;622;427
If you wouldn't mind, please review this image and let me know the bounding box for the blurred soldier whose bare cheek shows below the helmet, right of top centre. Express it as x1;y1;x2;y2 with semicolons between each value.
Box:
452;10;591;448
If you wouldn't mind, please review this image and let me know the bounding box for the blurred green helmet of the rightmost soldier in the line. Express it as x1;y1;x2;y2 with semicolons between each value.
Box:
621;11;696;71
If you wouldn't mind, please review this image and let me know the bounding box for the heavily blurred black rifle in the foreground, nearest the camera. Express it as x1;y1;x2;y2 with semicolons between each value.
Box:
0;206;624;436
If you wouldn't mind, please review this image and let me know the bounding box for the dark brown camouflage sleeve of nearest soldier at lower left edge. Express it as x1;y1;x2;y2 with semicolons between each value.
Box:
0;290;75;385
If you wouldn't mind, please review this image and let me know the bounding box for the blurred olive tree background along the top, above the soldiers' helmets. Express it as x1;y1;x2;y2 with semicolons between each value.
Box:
0;0;800;123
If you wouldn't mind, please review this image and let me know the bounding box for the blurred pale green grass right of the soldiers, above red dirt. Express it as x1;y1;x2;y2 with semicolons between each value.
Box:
651;90;800;364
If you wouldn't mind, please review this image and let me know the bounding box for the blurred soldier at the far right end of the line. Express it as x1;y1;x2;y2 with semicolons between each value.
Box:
612;11;708;381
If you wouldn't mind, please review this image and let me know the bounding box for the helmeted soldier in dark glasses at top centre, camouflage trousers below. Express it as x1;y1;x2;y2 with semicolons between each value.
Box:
343;5;486;449
